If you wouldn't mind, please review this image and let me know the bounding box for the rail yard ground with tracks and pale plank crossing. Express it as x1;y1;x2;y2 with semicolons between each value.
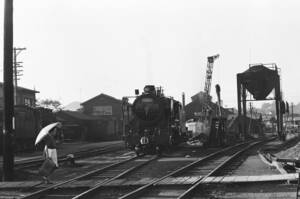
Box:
0;137;300;199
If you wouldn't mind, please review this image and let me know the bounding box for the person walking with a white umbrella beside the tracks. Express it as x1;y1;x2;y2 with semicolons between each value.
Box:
35;122;62;184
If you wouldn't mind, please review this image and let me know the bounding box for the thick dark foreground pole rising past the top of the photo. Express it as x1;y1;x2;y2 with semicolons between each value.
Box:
2;0;14;181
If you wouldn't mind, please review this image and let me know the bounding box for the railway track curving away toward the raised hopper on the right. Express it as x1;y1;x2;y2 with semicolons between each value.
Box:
116;142;260;199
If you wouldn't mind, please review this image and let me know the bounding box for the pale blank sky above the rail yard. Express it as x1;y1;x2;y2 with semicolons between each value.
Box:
0;0;300;107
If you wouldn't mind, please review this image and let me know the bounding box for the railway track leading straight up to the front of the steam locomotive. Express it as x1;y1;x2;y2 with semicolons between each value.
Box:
22;156;158;199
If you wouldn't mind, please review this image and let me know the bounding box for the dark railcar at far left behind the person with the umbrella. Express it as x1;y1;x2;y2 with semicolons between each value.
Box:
0;105;55;153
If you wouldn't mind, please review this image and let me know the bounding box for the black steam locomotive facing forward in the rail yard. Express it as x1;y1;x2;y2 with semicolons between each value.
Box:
123;85;186;155
